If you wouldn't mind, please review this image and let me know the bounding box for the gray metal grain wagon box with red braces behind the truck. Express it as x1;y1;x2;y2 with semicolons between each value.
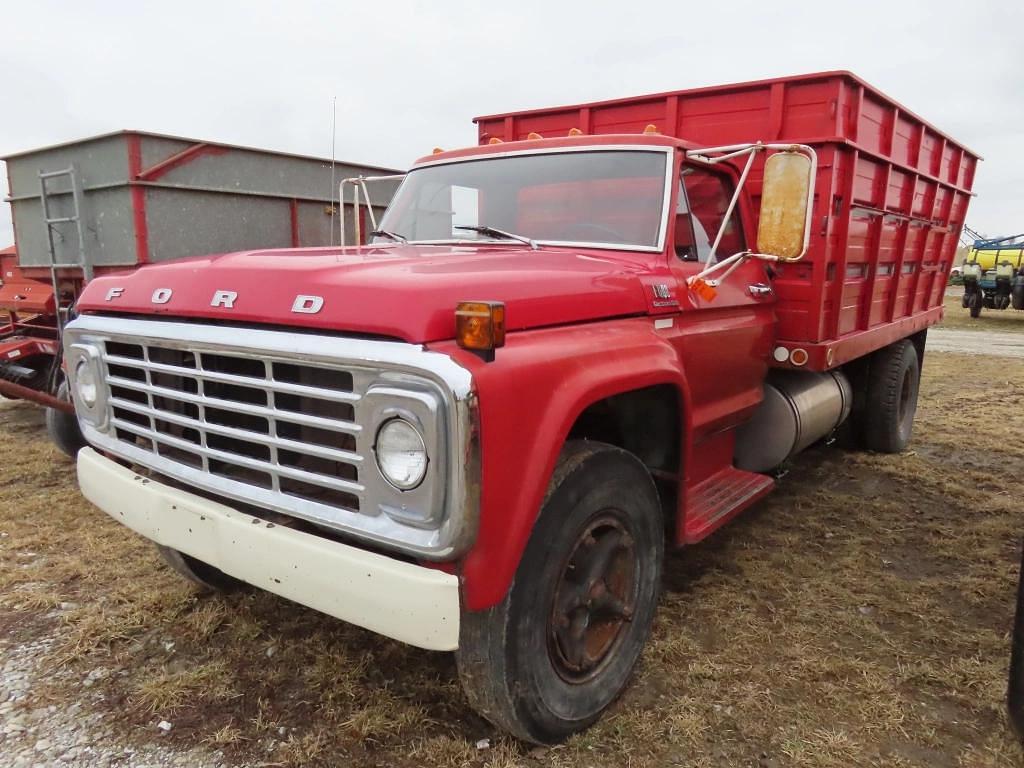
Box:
2;131;398;278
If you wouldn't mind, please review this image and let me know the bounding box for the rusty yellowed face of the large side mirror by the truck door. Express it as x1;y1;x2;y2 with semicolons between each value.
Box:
758;152;811;259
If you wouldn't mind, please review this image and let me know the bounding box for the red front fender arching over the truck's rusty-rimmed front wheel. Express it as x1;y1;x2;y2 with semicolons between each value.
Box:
432;317;690;610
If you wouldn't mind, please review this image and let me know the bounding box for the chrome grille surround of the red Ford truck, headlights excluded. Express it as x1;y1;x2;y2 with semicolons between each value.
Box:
65;315;479;559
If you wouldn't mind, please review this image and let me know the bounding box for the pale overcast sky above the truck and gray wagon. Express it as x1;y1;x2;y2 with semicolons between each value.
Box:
0;0;1024;247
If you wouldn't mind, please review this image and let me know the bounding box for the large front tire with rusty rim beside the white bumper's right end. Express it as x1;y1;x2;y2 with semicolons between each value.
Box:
456;441;665;743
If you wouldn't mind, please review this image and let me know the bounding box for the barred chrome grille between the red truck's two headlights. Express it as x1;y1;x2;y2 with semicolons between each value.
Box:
102;339;365;512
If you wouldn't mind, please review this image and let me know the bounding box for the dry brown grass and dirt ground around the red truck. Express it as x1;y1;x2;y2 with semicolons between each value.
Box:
0;308;1024;768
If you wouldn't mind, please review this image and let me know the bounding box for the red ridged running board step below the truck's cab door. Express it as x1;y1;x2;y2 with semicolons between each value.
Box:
682;467;775;544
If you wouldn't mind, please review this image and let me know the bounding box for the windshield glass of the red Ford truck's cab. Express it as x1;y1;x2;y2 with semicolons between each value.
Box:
380;150;670;248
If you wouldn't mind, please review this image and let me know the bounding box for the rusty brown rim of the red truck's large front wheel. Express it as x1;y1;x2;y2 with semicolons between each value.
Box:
547;510;640;684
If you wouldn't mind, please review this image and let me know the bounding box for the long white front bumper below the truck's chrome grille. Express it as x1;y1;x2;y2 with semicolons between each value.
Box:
78;447;459;650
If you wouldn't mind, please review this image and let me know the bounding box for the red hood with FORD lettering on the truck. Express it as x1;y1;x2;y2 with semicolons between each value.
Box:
72;245;668;343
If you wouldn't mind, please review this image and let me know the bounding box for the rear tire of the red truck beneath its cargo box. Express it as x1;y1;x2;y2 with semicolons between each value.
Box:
864;339;921;454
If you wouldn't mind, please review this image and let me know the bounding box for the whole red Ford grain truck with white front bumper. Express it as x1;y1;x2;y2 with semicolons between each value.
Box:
58;72;978;742
